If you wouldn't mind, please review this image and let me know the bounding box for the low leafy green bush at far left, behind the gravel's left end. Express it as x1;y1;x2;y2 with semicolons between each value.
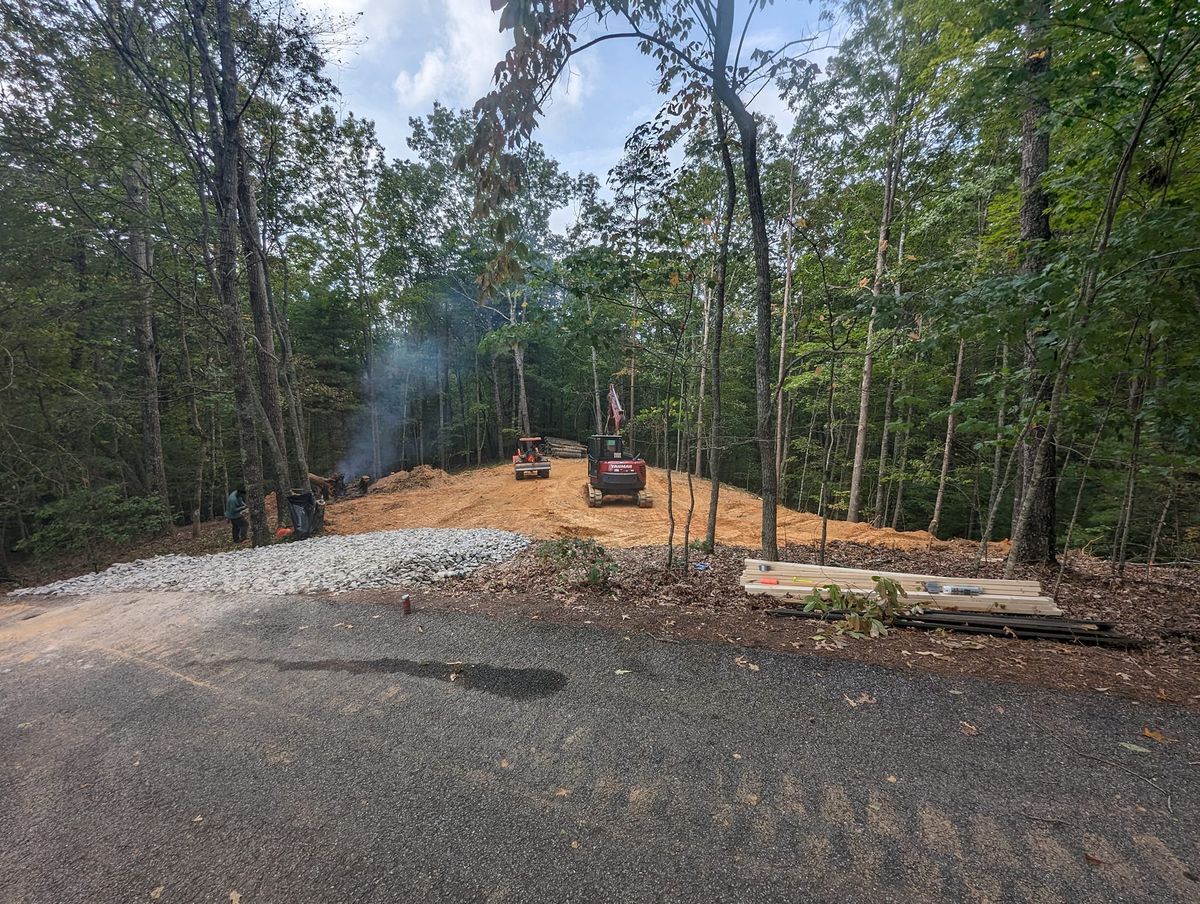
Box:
18;486;169;556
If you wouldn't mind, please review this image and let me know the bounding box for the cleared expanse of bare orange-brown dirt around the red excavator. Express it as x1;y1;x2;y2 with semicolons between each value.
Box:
325;459;960;549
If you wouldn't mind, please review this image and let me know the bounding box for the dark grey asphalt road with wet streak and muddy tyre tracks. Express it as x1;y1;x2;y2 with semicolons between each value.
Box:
0;594;1200;904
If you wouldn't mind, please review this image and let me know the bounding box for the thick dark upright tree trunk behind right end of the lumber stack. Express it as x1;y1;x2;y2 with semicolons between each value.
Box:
1010;0;1057;564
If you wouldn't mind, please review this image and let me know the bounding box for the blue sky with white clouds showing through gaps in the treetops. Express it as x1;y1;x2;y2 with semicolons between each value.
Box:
300;0;824;181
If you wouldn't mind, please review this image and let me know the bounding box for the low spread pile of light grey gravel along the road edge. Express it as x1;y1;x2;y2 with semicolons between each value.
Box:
10;527;529;597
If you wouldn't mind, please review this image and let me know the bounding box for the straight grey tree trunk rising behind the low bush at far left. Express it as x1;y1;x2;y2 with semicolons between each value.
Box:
125;161;170;515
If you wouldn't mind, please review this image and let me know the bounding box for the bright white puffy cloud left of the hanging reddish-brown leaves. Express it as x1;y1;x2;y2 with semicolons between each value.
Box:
392;0;511;112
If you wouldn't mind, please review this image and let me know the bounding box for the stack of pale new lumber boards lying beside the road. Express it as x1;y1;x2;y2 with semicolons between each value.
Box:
742;558;1062;616
